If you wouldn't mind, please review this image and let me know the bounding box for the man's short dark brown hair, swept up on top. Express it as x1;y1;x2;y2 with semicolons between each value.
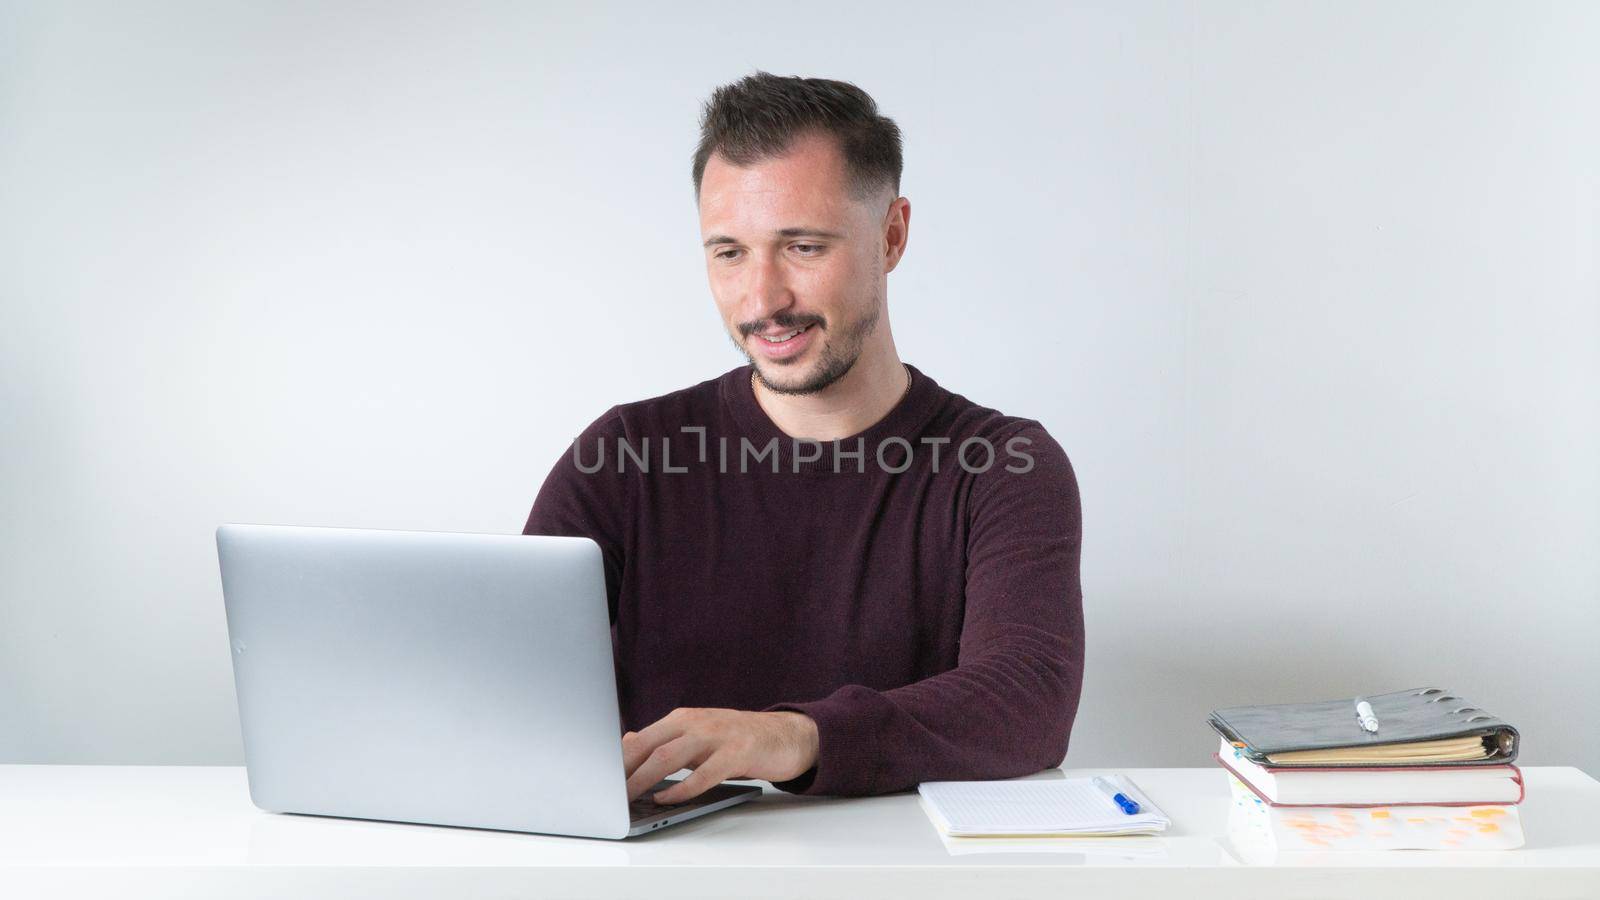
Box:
694;70;902;199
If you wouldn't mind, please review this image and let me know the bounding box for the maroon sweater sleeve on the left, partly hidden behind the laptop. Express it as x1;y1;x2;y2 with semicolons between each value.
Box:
522;407;630;626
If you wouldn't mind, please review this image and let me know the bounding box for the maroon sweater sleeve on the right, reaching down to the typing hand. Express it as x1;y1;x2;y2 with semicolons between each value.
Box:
766;423;1083;794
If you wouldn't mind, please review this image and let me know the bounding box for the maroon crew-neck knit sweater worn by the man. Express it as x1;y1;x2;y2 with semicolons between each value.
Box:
523;360;1083;794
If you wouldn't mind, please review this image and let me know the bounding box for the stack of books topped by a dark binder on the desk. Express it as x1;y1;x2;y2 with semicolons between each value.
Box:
1208;687;1523;855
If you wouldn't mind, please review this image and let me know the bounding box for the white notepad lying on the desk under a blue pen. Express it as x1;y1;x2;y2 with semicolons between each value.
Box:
917;775;1171;838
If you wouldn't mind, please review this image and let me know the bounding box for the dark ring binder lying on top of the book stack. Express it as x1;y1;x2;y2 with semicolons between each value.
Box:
1208;687;1522;767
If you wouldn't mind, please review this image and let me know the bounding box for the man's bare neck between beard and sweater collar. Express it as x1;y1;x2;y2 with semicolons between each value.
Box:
754;348;910;440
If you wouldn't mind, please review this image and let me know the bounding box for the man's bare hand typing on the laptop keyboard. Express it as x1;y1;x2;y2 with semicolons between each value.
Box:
622;706;818;804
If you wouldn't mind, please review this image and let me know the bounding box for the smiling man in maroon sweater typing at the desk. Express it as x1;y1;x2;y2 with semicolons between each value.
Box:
523;72;1083;804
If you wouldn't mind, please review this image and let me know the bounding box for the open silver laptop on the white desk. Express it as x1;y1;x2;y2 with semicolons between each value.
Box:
216;525;762;839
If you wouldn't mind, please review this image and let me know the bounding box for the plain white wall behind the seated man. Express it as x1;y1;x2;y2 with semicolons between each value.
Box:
0;0;1600;772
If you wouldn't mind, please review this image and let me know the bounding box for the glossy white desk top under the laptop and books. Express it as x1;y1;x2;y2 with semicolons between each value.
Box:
0;765;1600;900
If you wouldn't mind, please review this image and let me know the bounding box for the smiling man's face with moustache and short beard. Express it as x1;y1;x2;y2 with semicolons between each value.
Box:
699;135;893;394
